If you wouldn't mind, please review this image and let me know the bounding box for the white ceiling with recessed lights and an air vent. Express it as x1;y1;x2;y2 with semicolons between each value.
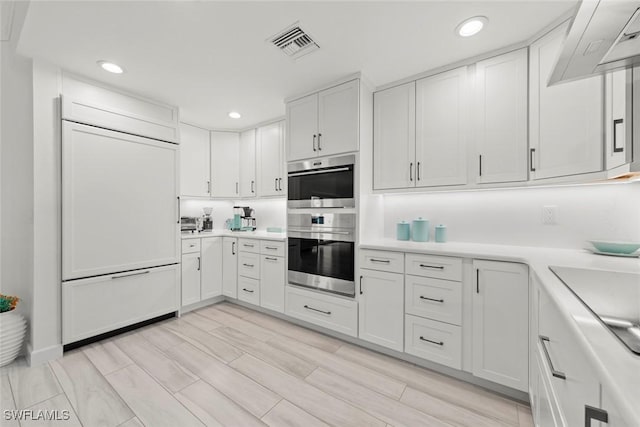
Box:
19;0;576;129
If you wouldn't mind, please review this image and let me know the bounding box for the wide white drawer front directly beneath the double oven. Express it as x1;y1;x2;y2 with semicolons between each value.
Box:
285;286;358;337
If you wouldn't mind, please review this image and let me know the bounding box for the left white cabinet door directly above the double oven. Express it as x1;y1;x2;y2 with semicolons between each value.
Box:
287;93;318;161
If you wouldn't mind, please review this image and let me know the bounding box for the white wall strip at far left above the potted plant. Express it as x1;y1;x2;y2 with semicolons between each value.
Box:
0;4;34;354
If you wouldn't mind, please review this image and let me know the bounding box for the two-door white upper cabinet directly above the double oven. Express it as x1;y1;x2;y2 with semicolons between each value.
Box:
287;79;360;161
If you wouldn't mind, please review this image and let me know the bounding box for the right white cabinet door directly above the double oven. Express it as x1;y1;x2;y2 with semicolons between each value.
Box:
318;80;360;156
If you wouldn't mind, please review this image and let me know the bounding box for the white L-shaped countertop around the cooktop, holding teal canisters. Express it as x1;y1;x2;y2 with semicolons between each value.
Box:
360;239;640;420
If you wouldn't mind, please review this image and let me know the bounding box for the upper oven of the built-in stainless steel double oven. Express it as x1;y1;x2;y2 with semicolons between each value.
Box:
288;155;355;208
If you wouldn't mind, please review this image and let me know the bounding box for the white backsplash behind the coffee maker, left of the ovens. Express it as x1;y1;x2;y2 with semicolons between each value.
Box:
180;198;287;230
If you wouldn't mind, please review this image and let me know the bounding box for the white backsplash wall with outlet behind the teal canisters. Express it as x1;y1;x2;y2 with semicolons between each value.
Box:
380;182;640;249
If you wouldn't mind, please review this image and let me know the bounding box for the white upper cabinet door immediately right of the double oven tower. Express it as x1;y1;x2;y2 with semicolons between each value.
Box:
373;82;416;190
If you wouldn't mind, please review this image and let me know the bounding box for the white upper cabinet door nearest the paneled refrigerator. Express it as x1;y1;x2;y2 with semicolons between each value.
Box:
180;123;211;197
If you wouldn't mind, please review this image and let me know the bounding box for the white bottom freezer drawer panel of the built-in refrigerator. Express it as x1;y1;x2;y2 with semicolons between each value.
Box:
62;264;180;344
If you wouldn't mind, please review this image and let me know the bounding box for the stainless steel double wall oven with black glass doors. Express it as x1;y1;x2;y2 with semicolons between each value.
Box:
287;155;357;297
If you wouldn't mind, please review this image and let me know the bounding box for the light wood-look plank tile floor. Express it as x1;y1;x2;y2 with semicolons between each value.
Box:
0;303;533;427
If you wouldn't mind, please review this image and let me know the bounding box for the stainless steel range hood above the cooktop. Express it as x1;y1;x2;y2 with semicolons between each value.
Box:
549;0;640;84
